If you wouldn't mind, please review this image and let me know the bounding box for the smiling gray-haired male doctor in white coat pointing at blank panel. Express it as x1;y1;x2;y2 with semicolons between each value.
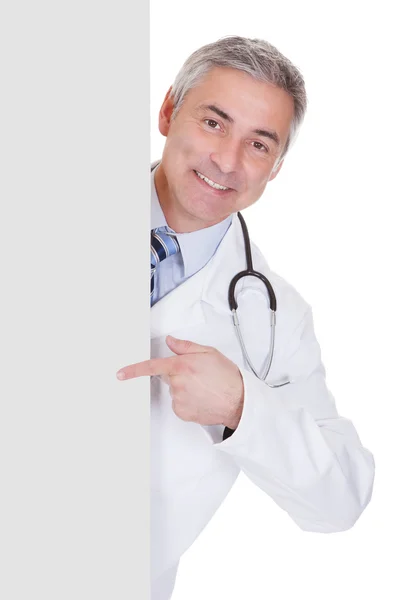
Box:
117;37;374;600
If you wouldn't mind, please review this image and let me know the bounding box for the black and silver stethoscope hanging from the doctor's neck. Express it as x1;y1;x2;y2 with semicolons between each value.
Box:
151;165;291;440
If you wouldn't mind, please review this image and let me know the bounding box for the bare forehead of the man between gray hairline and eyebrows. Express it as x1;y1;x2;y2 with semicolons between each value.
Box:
183;67;294;130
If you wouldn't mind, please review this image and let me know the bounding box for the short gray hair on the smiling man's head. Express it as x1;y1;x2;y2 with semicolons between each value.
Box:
171;36;307;162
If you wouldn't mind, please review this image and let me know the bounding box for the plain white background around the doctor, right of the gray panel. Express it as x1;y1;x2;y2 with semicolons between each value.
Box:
150;0;400;600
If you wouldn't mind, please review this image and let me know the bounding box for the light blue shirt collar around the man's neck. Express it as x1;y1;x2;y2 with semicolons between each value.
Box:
151;165;232;277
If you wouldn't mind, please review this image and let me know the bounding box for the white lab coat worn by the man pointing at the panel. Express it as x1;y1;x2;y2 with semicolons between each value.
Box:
151;215;374;600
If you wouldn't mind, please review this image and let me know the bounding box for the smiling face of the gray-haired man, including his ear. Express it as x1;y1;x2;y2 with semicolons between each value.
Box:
155;67;294;233
